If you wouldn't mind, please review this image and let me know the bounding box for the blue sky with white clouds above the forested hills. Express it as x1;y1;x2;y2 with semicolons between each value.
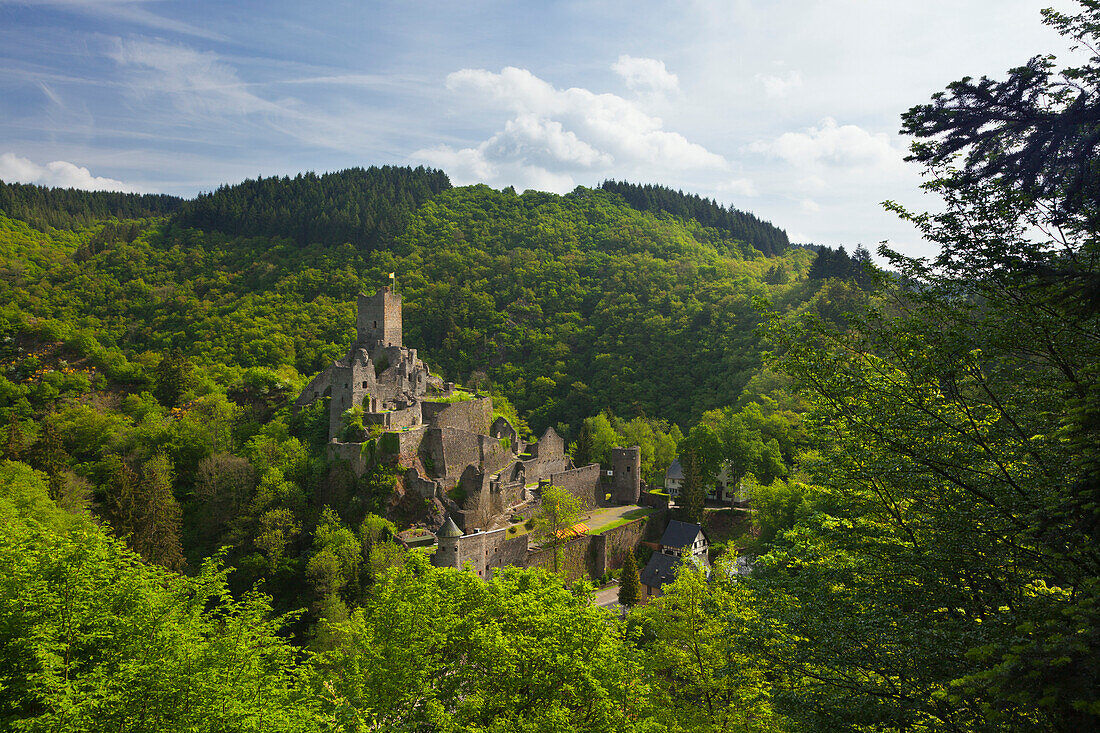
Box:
0;0;1076;255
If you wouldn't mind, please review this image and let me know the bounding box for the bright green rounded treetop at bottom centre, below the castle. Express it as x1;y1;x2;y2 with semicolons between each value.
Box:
315;555;647;731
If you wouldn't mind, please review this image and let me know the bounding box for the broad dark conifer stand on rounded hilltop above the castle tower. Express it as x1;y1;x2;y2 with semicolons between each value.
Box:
176;165;451;249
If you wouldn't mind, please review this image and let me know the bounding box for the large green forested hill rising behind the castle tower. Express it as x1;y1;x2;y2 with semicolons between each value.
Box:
0;174;855;431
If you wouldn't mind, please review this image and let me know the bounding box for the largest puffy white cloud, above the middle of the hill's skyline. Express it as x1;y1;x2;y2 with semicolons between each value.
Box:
413;66;726;192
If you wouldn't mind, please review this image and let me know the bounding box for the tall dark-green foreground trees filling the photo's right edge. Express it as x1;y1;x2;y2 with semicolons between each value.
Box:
759;2;1100;730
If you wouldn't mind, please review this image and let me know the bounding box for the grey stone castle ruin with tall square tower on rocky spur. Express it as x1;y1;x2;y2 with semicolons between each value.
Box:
295;287;611;533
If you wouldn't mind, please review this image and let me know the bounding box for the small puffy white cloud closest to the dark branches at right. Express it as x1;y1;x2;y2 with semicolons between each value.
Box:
748;118;903;171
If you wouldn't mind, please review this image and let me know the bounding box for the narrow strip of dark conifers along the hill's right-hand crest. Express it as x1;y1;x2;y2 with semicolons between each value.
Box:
600;180;791;255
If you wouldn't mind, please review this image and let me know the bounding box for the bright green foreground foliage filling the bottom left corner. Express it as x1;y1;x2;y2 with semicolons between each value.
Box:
0;490;316;732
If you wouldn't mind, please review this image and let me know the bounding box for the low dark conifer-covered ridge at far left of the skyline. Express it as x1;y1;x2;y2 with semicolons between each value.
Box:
0;180;184;231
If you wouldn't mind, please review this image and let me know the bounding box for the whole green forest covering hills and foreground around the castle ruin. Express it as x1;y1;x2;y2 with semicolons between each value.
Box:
0;2;1100;733
